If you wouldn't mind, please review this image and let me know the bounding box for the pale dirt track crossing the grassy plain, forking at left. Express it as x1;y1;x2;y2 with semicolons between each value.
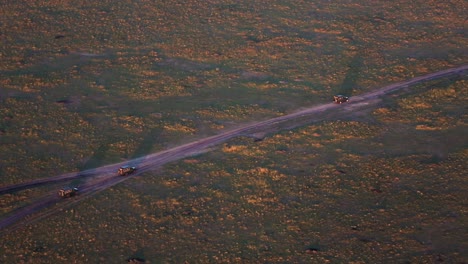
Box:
0;65;468;232
